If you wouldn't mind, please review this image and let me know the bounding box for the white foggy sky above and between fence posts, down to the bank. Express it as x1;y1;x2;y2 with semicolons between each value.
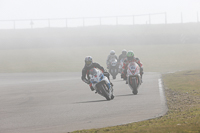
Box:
0;0;200;29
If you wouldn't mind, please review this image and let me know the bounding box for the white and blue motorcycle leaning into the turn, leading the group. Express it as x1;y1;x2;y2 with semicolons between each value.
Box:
89;68;114;100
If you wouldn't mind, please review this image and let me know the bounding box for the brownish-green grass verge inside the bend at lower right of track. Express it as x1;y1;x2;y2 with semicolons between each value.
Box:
73;70;200;133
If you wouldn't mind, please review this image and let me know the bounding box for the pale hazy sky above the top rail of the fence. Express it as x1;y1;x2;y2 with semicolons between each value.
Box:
0;0;200;27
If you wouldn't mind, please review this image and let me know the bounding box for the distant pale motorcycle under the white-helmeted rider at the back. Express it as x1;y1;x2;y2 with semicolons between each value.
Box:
109;59;118;79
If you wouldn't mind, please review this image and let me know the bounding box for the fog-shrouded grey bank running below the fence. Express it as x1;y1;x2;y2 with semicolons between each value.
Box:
0;23;200;49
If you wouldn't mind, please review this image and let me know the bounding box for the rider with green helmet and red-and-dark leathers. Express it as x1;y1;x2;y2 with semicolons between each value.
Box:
121;50;143;84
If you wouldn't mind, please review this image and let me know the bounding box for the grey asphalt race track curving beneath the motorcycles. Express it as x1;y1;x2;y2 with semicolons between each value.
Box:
0;72;167;133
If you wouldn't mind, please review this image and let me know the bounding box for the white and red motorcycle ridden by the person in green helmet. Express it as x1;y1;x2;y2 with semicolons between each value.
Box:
127;62;141;95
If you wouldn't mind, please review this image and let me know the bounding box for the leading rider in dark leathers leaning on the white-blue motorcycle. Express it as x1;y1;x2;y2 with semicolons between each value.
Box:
81;56;113;91
